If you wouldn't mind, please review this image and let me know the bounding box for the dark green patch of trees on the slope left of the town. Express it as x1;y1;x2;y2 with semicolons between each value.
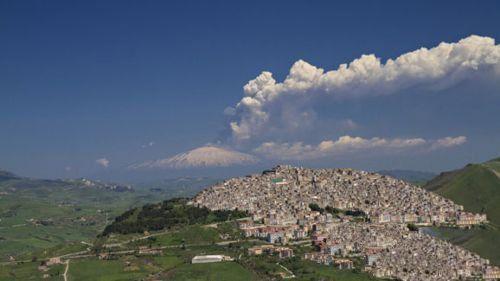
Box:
103;198;248;235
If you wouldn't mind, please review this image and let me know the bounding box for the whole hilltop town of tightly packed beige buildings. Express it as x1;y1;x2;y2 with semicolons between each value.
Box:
191;166;500;280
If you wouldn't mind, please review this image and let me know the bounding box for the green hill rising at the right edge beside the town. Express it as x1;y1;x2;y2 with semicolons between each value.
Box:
424;158;500;264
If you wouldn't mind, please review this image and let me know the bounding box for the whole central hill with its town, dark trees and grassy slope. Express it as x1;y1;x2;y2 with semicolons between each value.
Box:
0;166;494;281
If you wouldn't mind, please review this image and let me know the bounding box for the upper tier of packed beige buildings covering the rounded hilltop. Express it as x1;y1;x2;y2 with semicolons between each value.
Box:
194;166;486;225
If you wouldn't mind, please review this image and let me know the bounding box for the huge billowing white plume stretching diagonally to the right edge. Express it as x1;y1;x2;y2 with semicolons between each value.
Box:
228;35;500;144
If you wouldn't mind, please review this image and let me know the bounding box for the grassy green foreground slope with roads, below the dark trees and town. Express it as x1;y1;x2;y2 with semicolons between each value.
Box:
0;200;378;281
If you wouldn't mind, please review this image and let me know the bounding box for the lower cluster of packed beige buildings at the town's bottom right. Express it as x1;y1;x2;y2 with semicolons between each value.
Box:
314;223;490;281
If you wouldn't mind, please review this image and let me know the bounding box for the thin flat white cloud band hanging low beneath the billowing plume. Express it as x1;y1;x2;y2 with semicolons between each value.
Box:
254;136;466;160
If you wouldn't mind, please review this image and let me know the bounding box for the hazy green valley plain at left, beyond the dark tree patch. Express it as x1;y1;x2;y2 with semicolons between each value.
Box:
0;171;219;262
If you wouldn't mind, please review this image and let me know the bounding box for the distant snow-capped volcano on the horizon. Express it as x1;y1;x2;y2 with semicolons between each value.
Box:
129;145;258;169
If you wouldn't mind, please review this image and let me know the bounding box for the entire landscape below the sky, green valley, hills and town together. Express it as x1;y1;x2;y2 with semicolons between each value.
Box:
0;161;500;280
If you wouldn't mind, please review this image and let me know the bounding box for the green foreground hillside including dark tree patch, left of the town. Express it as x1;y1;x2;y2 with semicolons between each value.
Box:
0;195;381;281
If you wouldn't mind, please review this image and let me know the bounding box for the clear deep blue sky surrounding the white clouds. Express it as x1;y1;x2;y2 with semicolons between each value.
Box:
0;1;500;177
